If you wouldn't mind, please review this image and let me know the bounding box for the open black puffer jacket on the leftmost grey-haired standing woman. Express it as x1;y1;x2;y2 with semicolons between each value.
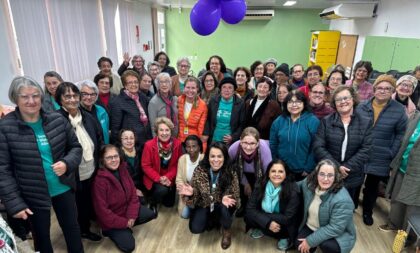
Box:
0;108;82;215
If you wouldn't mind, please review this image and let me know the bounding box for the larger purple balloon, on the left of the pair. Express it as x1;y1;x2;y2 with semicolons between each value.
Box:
190;0;221;36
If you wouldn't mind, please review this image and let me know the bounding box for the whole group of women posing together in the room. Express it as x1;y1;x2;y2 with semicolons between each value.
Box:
0;52;420;253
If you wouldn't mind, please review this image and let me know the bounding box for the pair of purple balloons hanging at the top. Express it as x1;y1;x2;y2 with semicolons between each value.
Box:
190;0;246;36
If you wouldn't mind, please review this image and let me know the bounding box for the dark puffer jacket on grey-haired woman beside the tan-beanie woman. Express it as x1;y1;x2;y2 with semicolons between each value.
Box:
313;112;372;188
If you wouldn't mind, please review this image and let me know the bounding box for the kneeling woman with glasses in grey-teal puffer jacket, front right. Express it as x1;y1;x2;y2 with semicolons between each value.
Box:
297;160;356;253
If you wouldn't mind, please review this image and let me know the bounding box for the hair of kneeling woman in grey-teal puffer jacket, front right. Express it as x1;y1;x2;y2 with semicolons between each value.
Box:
307;159;344;193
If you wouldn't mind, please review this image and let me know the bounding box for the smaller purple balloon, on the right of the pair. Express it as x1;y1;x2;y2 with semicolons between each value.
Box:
220;0;246;25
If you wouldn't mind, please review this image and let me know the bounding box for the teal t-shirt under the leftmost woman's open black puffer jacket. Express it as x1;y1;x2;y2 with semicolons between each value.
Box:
27;118;70;197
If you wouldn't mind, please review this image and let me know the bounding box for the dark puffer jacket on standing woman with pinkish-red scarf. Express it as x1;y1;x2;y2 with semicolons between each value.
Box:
109;89;154;148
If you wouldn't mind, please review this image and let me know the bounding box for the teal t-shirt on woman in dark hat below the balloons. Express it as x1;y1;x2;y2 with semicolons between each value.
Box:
212;97;233;142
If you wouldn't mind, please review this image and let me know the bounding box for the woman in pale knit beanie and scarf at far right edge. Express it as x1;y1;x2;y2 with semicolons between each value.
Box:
392;75;417;117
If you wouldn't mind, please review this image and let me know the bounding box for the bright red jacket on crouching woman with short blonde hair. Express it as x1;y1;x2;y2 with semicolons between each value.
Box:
141;137;182;190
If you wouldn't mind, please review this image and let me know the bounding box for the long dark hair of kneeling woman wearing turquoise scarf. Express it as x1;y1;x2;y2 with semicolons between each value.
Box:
255;159;294;203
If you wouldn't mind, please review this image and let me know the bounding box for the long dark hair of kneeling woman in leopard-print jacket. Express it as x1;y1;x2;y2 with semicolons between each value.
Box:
200;142;236;191
